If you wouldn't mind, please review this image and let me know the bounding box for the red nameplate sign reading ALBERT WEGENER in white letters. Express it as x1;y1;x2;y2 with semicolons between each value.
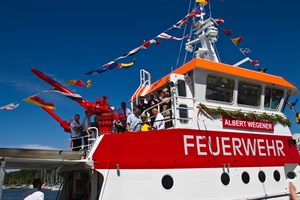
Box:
222;117;274;132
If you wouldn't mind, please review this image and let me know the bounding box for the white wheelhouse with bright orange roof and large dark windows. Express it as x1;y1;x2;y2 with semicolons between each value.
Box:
130;58;298;132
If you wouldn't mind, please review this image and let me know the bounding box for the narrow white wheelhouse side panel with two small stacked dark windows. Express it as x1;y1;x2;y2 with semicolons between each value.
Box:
170;74;195;128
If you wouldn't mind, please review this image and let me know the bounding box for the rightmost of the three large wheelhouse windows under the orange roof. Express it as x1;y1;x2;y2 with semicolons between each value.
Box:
264;88;283;109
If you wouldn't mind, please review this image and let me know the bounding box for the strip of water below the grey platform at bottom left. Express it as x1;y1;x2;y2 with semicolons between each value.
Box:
0;188;58;200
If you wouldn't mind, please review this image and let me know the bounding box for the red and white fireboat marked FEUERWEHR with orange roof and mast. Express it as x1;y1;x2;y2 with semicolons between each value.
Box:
0;0;300;200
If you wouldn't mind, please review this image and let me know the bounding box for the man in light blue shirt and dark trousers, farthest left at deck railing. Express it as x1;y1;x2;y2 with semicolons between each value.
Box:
70;114;82;151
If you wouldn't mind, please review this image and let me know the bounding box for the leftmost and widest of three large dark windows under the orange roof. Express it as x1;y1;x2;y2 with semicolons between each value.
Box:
206;75;234;102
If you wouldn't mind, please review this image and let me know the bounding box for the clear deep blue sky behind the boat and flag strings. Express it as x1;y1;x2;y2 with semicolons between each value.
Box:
0;0;300;149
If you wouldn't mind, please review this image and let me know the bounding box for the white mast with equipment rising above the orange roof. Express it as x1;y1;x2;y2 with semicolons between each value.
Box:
185;0;219;62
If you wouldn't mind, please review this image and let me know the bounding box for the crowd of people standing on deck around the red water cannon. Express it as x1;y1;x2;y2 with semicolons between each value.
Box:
70;88;172;151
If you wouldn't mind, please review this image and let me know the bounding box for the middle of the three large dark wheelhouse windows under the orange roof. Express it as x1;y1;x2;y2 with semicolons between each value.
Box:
238;82;261;106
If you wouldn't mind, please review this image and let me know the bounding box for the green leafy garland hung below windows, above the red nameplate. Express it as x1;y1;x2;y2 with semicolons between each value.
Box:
200;103;291;127
